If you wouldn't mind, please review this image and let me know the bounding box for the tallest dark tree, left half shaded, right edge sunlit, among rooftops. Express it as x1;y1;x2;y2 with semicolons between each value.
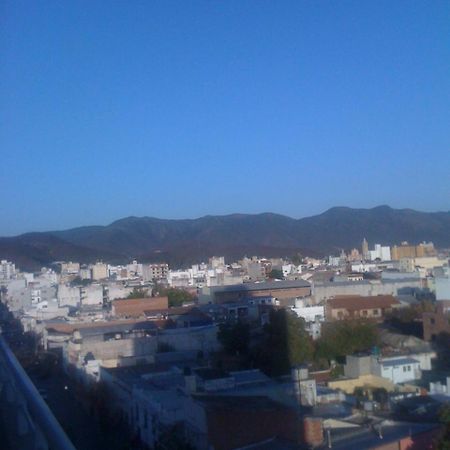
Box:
255;309;314;375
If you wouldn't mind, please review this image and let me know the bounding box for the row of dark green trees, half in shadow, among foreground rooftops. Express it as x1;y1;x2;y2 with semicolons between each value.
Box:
218;309;378;376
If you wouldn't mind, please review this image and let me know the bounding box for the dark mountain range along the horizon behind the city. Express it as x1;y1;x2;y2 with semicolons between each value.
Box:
0;206;450;270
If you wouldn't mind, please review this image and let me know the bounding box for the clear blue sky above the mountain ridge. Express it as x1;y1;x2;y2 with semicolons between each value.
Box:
0;0;450;235
